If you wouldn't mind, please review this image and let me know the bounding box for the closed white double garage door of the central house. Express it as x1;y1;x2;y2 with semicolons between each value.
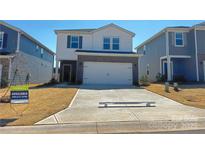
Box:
83;62;132;85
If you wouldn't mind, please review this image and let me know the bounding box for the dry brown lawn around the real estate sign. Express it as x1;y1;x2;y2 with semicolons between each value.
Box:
0;85;77;125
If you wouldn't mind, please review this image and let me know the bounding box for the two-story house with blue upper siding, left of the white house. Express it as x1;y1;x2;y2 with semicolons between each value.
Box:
0;21;54;84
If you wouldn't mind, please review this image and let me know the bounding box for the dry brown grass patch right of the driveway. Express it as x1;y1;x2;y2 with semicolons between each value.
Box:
146;84;205;109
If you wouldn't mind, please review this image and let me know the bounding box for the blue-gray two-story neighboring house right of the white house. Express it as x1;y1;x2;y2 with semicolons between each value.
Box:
135;23;205;82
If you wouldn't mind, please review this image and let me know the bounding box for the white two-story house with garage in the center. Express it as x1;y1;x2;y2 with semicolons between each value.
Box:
55;24;139;85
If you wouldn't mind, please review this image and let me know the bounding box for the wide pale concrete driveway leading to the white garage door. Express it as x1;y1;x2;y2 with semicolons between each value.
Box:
37;86;205;124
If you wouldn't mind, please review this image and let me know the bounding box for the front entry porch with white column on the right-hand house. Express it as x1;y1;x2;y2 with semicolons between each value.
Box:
160;56;196;82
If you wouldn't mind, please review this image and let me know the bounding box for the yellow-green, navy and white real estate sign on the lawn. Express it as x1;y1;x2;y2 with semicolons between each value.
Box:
10;84;29;104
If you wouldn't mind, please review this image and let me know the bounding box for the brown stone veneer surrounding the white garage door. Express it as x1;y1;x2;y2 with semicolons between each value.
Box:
76;55;138;85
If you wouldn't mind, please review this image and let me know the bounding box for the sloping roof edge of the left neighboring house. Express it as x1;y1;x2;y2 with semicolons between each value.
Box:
0;20;55;55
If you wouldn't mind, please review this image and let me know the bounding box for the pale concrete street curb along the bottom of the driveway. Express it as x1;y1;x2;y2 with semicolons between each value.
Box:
0;119;205;134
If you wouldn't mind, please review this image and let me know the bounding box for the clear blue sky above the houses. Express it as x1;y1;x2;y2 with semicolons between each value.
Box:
5;20;203;52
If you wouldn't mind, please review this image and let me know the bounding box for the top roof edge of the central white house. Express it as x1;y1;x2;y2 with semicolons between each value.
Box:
55;23;135;37
